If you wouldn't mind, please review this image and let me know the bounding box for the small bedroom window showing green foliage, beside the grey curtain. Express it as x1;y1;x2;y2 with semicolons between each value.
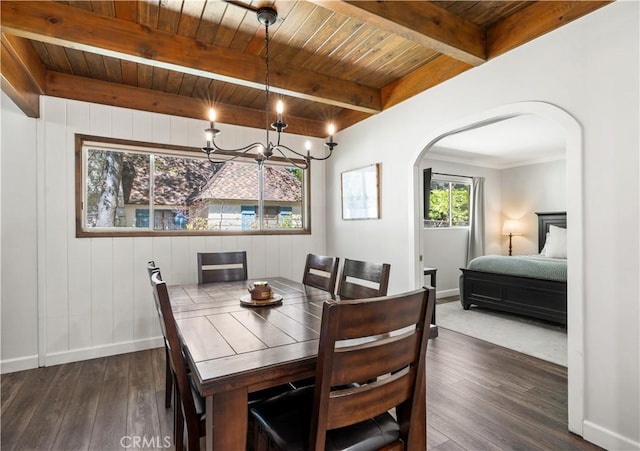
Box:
424;171;471;228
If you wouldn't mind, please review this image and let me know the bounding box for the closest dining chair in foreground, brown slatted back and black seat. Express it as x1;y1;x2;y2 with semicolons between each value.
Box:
250;288;435;451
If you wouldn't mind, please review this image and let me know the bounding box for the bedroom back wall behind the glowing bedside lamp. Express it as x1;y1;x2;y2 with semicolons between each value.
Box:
502;160;571;255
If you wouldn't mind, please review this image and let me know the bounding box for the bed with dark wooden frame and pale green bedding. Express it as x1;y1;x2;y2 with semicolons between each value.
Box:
460;212;567;325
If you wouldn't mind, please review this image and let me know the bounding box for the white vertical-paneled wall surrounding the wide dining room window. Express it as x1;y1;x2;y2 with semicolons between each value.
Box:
2;94;325;372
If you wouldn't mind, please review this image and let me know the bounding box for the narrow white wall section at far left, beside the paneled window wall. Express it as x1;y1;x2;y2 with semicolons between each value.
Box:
0;94;38;369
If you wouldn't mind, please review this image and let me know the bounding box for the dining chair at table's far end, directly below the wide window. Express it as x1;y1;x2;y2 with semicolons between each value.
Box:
198;251;248;284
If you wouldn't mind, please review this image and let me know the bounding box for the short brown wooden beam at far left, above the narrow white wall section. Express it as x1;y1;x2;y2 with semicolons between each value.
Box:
0;33;46;118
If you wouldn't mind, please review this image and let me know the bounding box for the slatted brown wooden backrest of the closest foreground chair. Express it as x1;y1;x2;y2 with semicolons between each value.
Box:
309;288;435;449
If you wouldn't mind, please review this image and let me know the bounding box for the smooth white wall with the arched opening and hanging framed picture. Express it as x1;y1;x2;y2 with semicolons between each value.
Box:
326;1;640;449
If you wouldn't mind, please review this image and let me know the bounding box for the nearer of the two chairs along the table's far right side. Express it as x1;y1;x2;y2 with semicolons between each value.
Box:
337;258;391;299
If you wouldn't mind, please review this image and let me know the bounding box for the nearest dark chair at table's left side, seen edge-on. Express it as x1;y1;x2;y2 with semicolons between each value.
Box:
151;272;206;451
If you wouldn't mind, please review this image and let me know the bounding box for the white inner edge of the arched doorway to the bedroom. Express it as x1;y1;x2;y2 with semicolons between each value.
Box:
412;102;584;435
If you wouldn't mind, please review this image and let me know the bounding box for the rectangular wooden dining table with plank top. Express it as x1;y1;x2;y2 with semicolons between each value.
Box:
168;277;426;451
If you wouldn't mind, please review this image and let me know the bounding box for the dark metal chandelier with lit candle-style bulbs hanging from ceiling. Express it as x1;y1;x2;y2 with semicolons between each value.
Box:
202;6;338;169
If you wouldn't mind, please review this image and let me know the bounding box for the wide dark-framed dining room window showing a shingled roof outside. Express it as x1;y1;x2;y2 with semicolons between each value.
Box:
76;135;310;236
